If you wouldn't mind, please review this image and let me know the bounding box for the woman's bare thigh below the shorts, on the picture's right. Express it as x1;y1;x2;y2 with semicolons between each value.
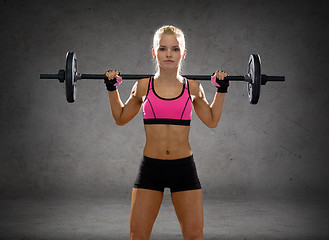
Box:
171;189;204;240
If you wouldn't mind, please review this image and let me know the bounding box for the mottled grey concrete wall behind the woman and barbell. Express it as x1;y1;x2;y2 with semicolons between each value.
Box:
0;0;329;197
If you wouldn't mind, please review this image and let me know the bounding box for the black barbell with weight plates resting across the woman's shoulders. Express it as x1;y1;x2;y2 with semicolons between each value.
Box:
40;52;285;104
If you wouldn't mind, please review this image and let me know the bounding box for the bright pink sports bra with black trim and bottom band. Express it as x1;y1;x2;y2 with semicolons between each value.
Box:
143;77;192;126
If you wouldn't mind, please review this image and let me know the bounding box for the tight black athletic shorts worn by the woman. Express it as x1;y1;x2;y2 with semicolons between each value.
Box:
134;155;201;192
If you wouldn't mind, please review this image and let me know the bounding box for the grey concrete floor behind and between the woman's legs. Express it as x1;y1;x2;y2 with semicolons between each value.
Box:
0;192;329;240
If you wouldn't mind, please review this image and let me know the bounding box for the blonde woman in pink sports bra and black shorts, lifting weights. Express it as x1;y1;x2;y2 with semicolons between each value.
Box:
105;26;229;240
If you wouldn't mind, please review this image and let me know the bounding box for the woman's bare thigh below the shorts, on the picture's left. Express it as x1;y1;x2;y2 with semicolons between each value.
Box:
129;188;163;240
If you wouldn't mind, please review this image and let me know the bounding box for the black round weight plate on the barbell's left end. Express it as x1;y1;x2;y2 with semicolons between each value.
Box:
65;52;77;103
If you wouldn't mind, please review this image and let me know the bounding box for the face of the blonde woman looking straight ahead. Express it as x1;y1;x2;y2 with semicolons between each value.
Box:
152;34;186;70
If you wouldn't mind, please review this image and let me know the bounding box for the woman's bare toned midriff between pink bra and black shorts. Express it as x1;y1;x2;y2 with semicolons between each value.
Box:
144;124;192;160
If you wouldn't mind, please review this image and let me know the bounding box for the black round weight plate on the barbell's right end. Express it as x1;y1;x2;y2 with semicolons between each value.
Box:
247;54;261;104
